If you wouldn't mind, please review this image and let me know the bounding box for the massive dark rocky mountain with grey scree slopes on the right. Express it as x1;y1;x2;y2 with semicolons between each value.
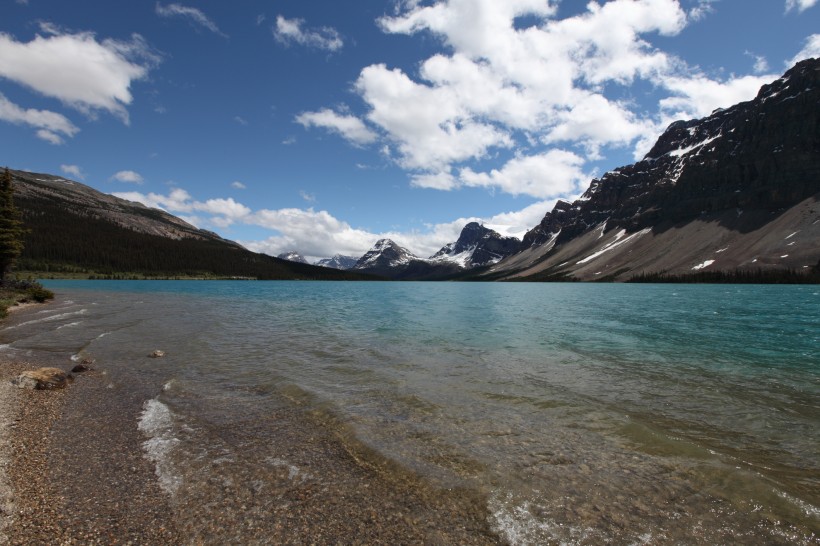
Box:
483;59;820;280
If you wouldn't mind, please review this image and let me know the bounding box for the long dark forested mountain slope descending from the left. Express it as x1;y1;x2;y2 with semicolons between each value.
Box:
10;171;370;280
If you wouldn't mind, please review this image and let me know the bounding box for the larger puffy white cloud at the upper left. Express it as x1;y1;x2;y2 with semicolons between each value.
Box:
0;24;159;122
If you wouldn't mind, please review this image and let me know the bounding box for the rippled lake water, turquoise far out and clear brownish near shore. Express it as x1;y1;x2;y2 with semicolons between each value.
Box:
0;281;820;544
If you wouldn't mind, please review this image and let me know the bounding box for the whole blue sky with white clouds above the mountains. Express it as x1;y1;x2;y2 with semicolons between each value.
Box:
0;0;820;260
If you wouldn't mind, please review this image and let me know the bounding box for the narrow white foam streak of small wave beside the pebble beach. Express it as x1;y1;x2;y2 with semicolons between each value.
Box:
137;398;182;495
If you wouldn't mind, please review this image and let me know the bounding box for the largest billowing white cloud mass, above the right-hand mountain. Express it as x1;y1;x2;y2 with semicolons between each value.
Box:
297;0;773;199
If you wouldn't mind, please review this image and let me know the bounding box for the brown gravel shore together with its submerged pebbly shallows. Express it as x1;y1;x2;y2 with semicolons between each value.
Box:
0;320;503;545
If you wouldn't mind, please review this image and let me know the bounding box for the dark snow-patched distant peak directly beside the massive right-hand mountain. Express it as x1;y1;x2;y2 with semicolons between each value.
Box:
430;222;521;269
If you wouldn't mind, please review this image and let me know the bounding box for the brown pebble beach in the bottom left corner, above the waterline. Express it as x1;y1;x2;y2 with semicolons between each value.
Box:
0;356;182;545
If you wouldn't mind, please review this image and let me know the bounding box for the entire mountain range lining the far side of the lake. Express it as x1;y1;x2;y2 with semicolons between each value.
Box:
12;59;820;282
